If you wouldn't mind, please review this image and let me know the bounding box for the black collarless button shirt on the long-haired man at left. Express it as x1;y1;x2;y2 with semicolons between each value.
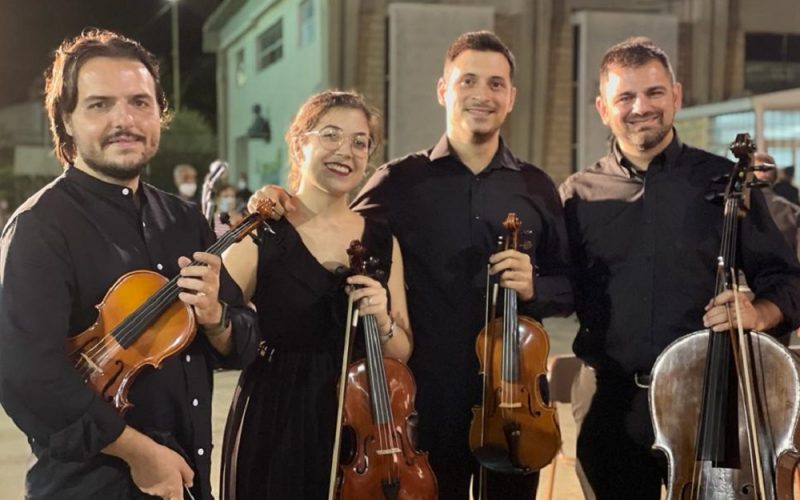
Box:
0;167;257;499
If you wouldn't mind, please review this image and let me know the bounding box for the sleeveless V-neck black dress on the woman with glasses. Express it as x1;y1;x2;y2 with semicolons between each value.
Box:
221;219;392;500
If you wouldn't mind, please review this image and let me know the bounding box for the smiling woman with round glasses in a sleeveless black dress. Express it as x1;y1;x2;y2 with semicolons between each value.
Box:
221;91;411;500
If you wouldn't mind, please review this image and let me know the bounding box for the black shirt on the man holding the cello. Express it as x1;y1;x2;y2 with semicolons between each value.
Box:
561;135;800;374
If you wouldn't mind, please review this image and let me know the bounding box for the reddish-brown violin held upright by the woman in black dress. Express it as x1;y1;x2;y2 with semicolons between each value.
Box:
329;240;438;500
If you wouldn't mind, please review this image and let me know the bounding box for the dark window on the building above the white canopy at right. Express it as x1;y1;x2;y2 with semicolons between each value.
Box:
744;33;800;94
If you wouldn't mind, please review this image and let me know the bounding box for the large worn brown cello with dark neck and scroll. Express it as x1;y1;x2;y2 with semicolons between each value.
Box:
649;134;800;500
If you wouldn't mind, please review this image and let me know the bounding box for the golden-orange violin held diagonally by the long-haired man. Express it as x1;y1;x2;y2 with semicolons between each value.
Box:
66;200;275;414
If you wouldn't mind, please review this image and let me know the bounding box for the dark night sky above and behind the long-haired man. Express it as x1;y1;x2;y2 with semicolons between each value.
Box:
0;0;220;117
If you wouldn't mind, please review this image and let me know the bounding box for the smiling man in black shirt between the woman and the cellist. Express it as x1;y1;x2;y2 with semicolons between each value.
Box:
353;32;572;500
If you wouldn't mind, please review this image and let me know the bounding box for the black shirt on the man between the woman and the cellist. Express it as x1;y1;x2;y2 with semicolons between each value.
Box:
353;136;572;425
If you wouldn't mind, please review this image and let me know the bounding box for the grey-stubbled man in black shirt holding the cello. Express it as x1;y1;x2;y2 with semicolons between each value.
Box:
560;38;800;500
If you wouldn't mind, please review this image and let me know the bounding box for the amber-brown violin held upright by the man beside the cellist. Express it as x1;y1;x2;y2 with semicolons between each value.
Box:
469;213;561;484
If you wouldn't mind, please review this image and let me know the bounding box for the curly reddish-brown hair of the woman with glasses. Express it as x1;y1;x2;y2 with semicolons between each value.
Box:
286;90;383;191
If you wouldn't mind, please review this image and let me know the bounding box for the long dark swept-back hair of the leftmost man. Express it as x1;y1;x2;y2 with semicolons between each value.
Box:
44;29;168;165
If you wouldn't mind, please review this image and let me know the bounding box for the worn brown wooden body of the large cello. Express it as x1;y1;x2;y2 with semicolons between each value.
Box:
650;330;800;500
